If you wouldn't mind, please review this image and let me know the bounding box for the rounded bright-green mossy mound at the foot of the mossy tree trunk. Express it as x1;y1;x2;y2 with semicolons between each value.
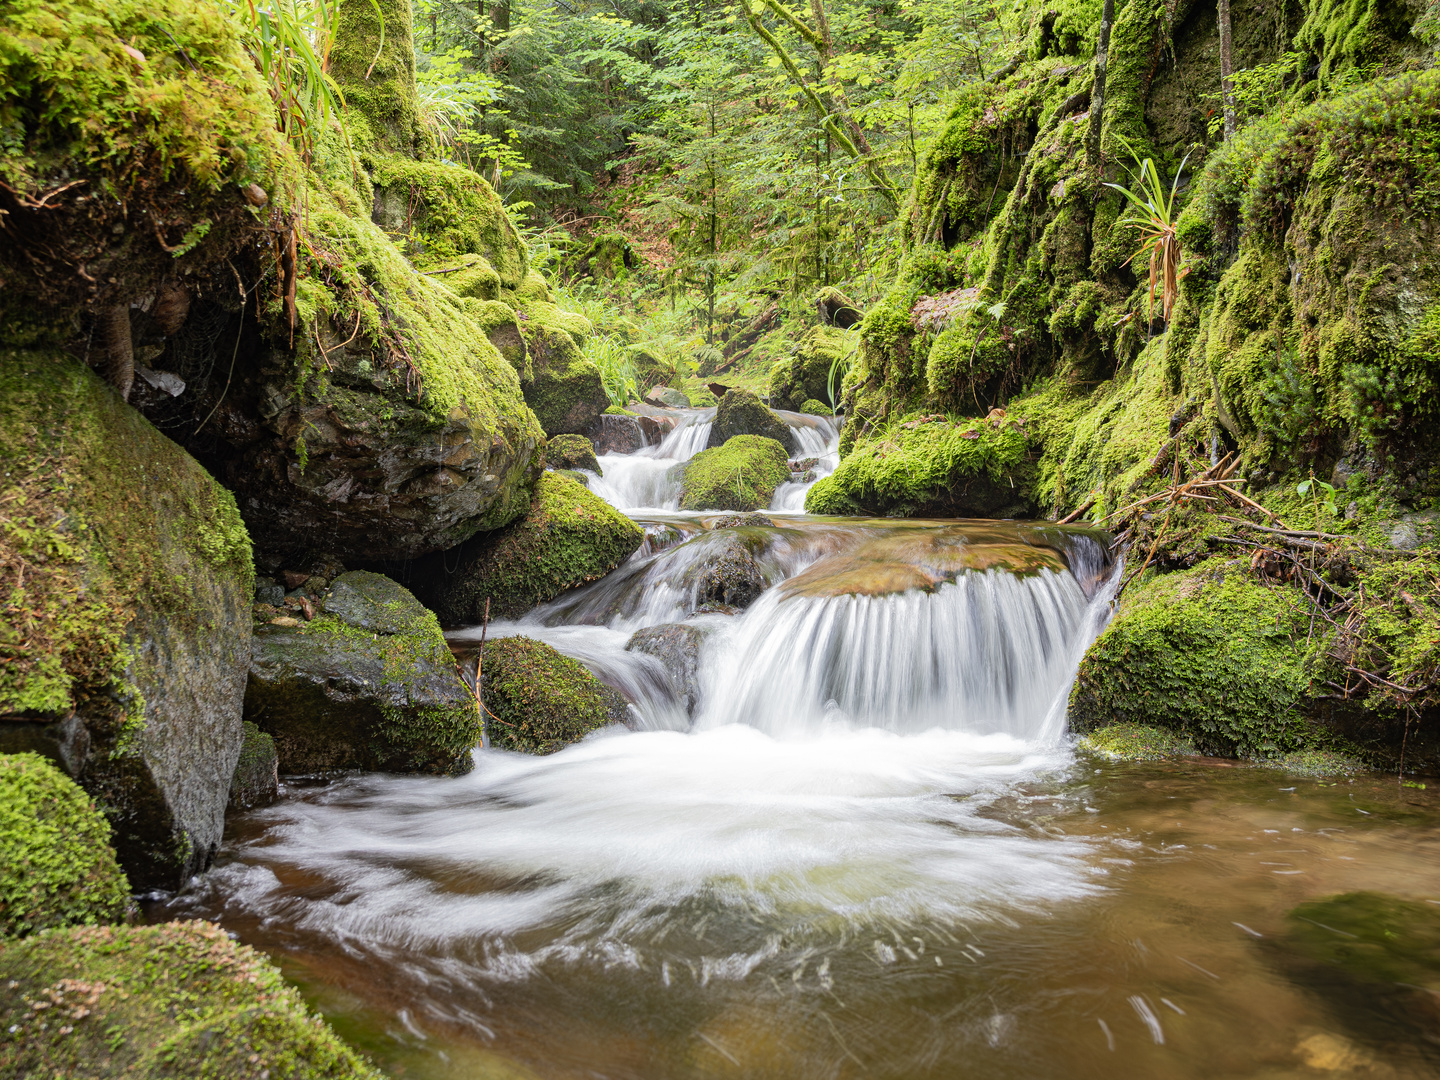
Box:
372;156;527;285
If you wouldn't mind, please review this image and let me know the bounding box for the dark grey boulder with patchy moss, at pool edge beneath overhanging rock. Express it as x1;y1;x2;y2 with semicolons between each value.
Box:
245;570;480;775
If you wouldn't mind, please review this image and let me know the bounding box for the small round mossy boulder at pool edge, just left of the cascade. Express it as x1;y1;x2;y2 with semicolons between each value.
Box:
484;638;628;753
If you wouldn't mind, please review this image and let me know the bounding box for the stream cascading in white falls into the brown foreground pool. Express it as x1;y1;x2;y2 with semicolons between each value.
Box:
163;410;1440;1080
